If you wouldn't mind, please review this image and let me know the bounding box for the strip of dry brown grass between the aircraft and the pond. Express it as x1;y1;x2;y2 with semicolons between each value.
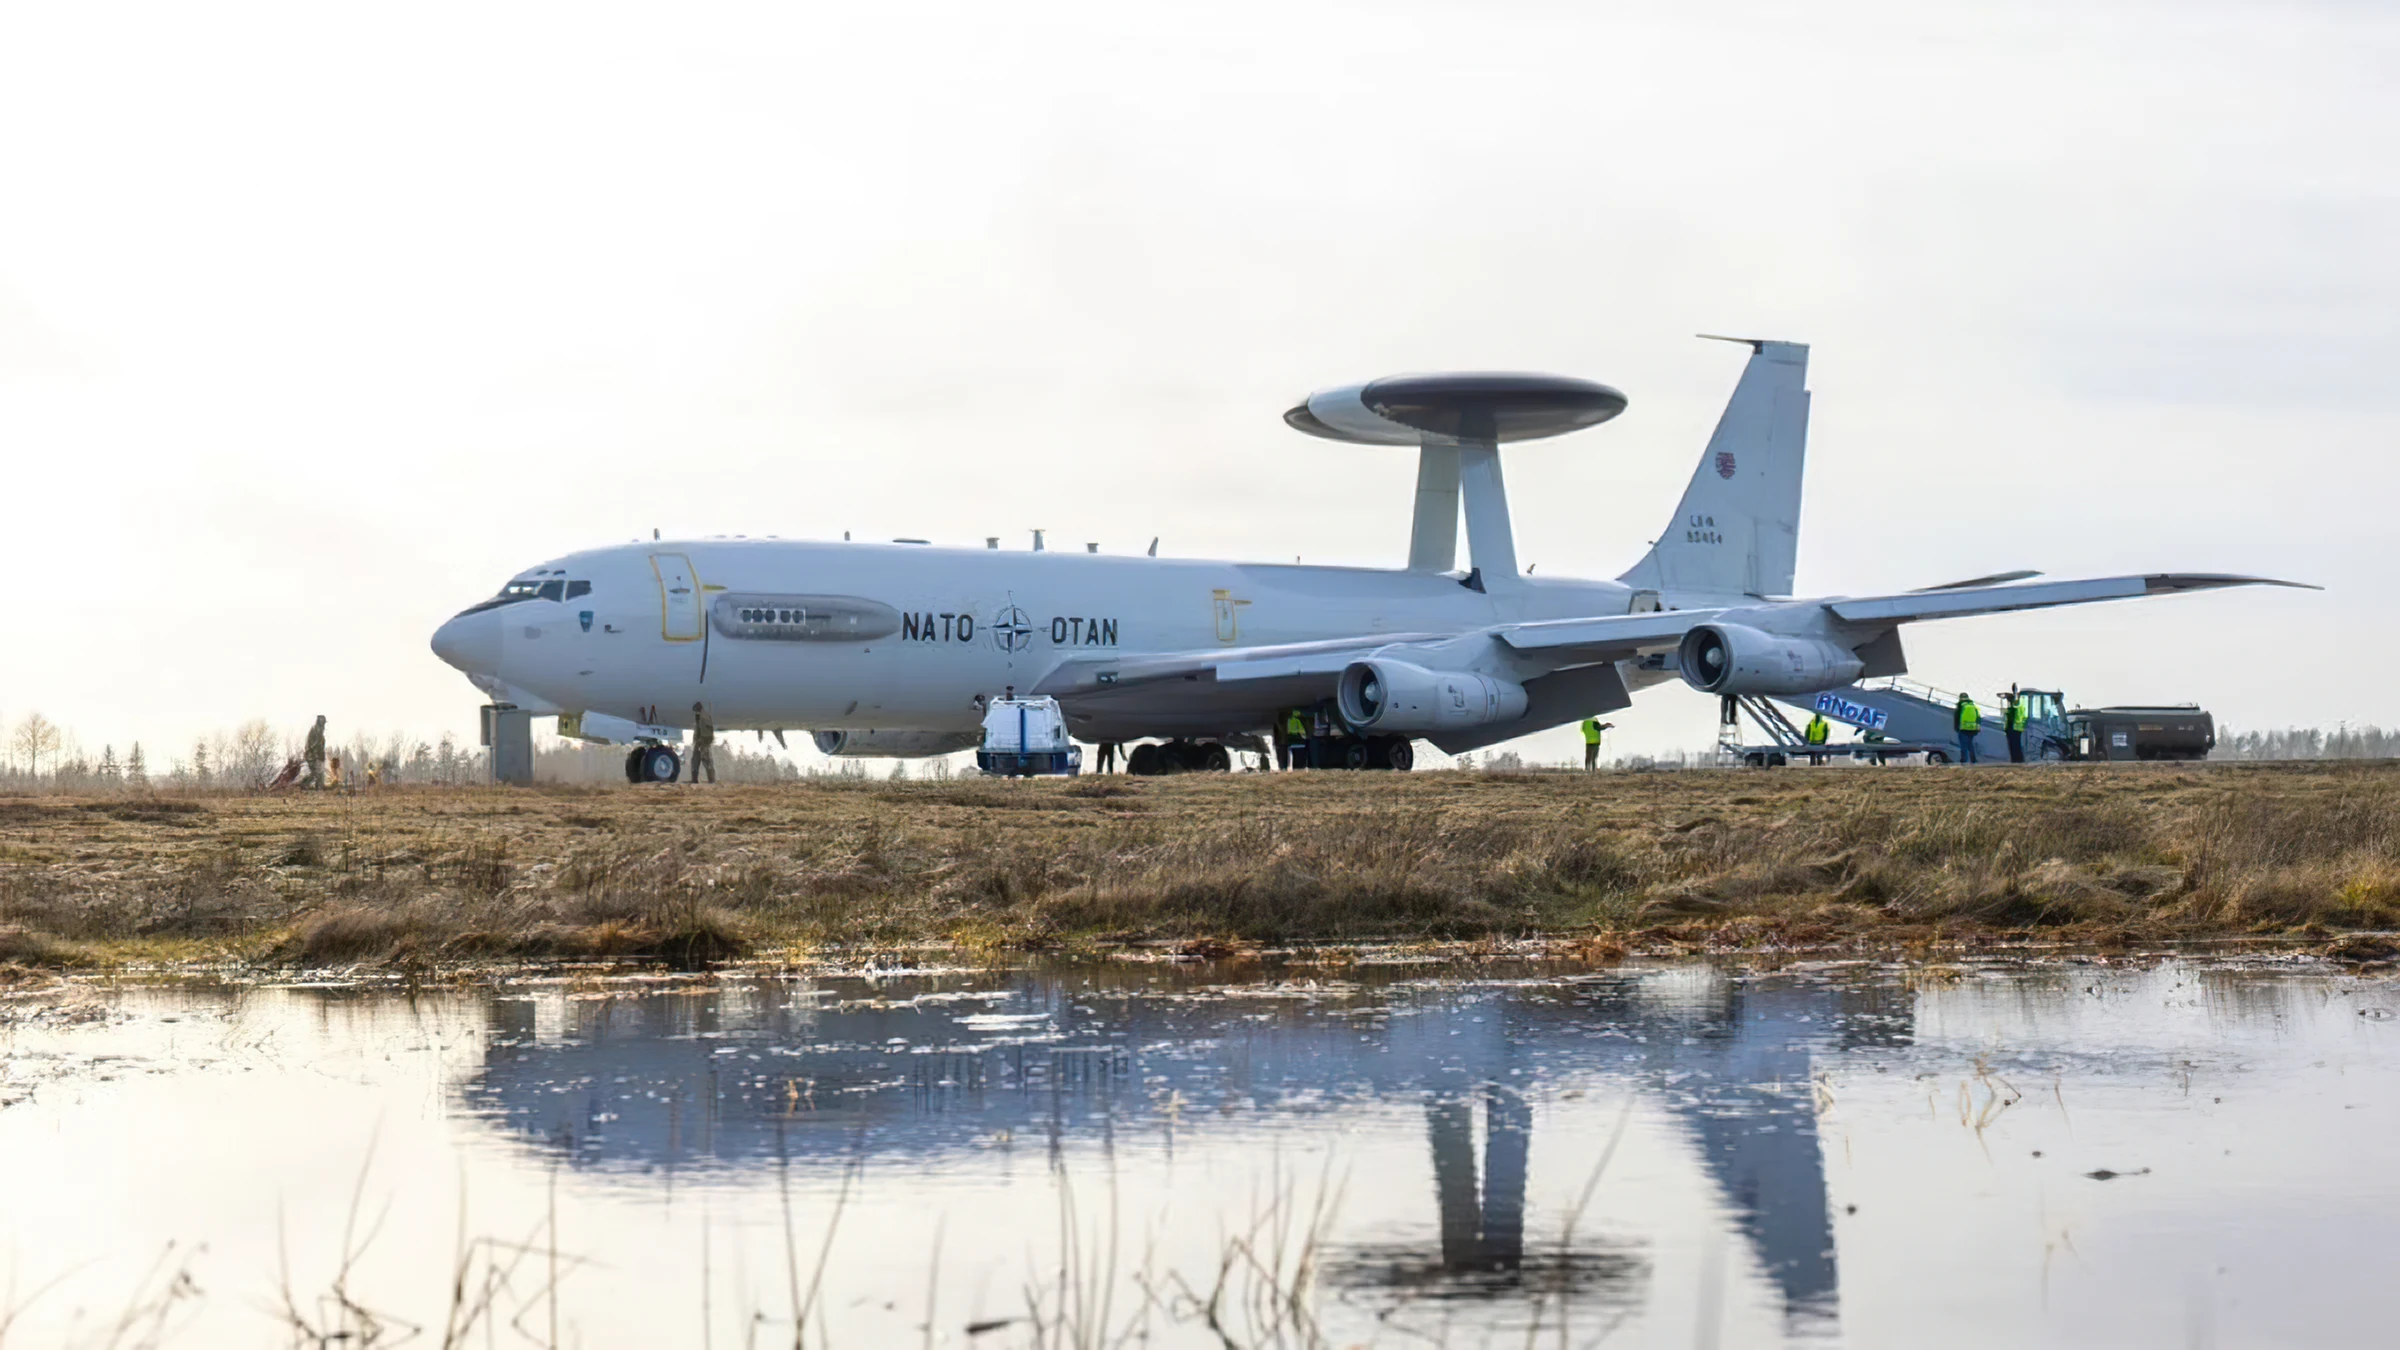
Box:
0;764;2400;968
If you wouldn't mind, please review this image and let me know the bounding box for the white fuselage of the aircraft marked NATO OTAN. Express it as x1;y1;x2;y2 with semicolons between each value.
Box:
434;540;1670;740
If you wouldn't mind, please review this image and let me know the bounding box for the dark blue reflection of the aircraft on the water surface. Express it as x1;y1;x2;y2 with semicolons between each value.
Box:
466;968;1910;1333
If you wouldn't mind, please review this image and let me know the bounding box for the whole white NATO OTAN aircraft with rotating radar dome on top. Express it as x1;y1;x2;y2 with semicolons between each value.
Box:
434;339;2282;778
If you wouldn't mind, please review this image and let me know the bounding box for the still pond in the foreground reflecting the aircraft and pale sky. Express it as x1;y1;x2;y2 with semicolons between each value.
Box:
0;958;2400;1348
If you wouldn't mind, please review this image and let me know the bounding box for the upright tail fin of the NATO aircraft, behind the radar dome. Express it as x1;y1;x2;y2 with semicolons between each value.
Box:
1622;339;1807;596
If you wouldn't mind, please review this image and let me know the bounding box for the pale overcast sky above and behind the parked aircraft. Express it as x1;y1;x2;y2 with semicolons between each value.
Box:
0;0;2400;764
